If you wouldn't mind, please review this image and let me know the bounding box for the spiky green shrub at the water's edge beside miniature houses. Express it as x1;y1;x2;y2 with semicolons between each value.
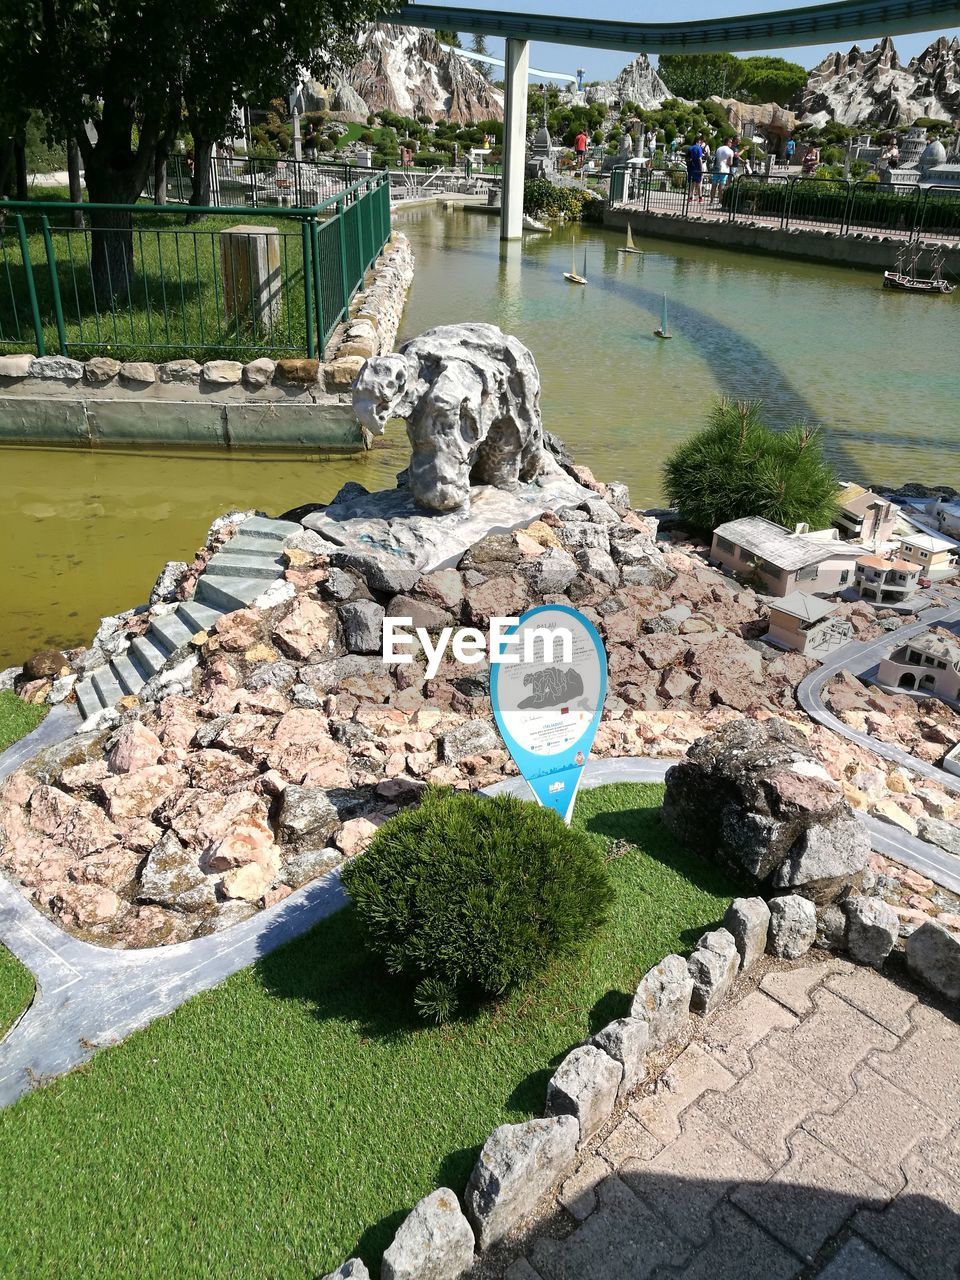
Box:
663;399;838;532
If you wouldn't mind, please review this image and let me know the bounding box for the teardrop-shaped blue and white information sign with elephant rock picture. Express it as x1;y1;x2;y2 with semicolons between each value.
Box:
490;604;607;823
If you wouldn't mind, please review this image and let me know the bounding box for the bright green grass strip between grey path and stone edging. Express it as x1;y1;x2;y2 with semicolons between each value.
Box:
0;786;740;1280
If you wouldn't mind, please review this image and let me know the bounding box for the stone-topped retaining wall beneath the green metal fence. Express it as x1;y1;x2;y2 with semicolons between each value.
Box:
0;232;413;452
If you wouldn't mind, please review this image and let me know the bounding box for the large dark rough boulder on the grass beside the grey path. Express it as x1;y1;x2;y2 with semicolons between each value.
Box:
663;719;870;904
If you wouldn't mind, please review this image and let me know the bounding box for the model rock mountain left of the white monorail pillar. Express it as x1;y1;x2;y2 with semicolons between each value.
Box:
320;24;503;124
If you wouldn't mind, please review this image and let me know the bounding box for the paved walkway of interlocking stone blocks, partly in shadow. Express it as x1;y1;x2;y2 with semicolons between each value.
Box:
506;957;960;1280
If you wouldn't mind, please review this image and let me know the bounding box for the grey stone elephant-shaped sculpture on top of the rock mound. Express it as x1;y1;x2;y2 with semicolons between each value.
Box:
353;324;544;511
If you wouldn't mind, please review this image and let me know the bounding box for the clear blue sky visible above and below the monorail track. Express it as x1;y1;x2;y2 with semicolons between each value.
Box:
461;0;960;81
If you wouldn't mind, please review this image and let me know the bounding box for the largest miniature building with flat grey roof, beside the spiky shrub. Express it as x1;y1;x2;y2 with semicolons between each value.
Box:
710;516;864;596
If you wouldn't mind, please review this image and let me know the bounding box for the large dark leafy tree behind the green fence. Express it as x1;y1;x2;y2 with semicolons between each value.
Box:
0;0;385;296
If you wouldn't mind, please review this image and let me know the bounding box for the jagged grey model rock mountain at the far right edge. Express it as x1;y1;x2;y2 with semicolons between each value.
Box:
797;36;960;125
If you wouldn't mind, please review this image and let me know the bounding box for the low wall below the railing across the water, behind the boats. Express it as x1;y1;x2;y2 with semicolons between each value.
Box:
603;205;960;271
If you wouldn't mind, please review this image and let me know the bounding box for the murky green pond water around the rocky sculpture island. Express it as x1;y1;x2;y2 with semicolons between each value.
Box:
0;209;960;667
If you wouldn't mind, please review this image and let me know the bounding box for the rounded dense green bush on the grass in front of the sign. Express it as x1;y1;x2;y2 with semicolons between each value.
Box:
343;787;613;1021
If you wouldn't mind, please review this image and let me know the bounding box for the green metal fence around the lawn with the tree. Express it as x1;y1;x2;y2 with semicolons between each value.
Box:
0;173;390;360
